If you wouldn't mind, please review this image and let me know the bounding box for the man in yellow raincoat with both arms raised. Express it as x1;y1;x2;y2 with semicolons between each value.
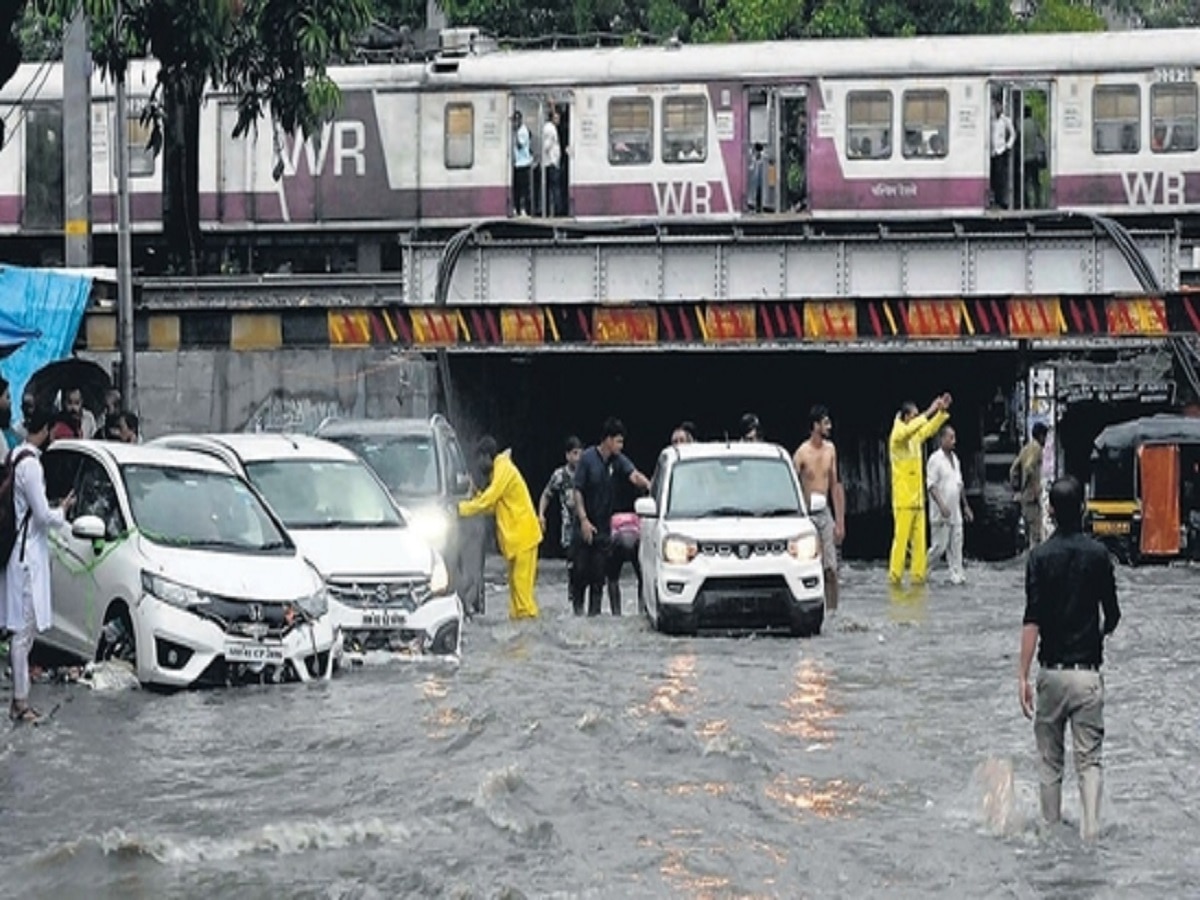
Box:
888;394;950;584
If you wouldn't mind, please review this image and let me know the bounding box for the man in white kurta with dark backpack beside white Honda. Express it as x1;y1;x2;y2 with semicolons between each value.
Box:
2;409;74;721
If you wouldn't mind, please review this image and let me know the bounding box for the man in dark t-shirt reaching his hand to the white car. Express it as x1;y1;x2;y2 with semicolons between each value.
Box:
572;419;650;616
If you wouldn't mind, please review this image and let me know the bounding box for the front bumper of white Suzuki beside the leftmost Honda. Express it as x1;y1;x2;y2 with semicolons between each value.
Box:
331;594;463;662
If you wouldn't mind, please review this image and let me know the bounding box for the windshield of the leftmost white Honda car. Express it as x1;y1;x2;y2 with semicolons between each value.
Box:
121;466;292;552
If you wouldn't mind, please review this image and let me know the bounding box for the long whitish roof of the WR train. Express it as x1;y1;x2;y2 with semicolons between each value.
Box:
0;29;1200;102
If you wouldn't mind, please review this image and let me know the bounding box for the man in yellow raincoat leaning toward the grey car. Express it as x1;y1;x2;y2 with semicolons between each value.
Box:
458;437;541;619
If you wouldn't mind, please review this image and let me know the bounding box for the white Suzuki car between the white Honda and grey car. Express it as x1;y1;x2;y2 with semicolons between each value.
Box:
152;433;463;661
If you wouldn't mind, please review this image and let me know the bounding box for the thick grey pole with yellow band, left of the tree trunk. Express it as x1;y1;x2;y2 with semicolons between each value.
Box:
62;7;91;269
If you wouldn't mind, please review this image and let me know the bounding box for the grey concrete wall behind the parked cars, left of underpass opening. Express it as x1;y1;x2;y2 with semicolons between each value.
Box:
82;348;438;438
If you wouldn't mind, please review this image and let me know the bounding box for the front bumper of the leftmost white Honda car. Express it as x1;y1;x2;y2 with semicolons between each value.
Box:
133;595;341;688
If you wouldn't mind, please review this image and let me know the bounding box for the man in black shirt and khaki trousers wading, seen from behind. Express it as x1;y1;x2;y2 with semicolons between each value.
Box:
1018;475;1121;840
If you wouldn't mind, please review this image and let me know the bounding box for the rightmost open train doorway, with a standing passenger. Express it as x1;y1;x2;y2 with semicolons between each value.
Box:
985;79;1055;210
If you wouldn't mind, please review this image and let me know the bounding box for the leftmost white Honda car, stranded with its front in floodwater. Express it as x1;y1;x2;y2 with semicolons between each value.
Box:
38;440;341;688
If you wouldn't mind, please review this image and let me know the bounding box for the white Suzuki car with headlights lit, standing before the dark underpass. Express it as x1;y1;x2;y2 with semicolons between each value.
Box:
635;443;824;635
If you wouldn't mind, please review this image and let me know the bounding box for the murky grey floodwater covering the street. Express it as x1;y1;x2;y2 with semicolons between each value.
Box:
0;560;1200;899
